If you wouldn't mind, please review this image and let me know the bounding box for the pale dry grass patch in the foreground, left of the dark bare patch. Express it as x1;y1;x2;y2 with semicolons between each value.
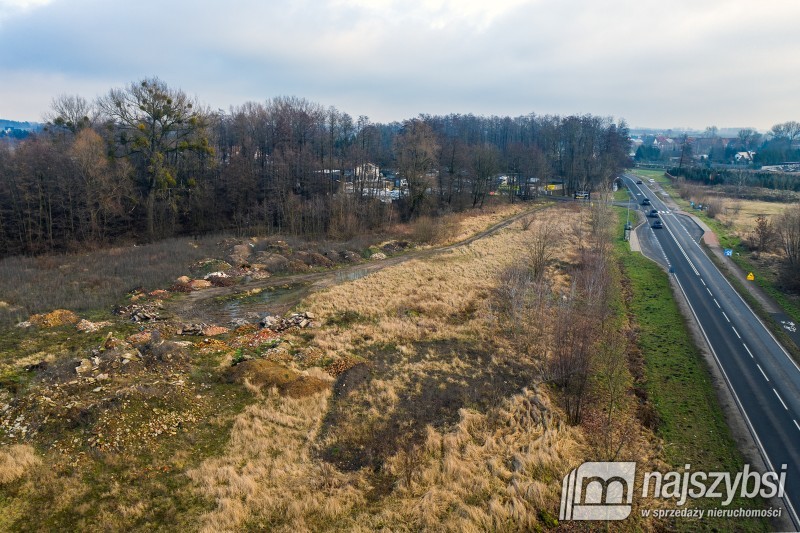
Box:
189;390;364;532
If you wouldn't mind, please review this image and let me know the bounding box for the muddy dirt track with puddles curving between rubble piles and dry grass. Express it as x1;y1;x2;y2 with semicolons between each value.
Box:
169;204;545;325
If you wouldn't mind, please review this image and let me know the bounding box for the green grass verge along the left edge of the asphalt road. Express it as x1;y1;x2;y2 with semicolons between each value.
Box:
616;209;769;531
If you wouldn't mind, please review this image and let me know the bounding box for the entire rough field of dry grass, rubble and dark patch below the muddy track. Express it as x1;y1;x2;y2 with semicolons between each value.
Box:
0;204;688;532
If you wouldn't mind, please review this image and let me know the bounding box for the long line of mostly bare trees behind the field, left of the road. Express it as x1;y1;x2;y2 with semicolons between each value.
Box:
0;78;629;255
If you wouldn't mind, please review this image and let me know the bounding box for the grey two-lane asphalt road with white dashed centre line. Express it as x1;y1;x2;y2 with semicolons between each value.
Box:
624;175;800;530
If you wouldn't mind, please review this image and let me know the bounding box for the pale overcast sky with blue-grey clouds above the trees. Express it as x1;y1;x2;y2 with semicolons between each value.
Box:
0;0;800;130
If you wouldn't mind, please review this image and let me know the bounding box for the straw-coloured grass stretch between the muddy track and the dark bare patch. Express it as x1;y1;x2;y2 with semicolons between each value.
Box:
294;204;574;357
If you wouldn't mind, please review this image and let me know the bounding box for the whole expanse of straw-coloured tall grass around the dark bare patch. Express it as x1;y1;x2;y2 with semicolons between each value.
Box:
189;203;585;531
